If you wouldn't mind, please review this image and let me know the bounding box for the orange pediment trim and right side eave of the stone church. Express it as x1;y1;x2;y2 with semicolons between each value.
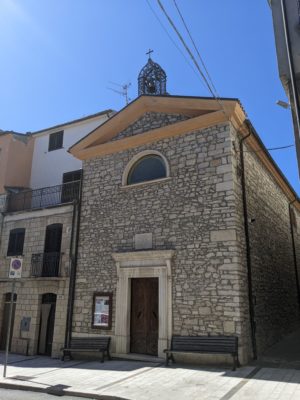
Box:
69;95;300;209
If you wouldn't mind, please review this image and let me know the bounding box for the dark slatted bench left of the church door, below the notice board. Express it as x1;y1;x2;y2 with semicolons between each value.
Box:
61;336;111;362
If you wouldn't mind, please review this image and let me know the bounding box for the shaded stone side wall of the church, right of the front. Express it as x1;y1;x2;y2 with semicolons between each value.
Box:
232;129;300;355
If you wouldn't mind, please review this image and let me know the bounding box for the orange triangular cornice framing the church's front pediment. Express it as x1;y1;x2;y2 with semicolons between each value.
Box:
69;96;246;160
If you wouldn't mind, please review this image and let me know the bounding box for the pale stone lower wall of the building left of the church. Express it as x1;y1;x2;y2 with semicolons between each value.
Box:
0;206;73;357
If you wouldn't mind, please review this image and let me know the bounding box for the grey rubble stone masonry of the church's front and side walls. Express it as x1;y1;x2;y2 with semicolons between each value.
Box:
72;113;300;362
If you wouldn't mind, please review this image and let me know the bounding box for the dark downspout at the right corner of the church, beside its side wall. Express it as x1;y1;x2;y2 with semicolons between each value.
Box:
239;129;257;360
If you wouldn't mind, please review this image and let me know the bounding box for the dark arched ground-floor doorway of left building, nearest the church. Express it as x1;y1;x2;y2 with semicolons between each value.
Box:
38;293;56;356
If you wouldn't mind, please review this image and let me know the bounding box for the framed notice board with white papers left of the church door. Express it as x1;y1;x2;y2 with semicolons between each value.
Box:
93;293;112;329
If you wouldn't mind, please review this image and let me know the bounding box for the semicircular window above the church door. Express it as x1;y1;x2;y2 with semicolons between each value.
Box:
127;154;167;185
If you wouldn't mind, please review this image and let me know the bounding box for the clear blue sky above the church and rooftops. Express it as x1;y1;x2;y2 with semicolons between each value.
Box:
0;0;300;193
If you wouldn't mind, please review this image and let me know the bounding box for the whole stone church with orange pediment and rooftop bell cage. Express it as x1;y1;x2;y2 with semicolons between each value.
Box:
70;59;300;362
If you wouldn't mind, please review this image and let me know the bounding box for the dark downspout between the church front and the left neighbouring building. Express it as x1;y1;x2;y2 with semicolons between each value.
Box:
65;178;83;347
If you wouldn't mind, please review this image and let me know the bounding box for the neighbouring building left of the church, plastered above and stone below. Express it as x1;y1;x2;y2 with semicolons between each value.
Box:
0;110;112;356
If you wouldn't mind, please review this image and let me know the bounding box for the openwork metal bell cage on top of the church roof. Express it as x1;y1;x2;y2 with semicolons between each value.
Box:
138;50;167;96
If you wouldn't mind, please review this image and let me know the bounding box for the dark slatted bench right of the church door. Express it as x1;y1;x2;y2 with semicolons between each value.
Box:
164;336;240;371
